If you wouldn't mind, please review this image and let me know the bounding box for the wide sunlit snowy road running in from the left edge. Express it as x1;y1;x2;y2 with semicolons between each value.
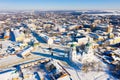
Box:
0;45;45;69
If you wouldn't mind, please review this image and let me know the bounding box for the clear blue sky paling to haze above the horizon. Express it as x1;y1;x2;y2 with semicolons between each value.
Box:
0;0;120;10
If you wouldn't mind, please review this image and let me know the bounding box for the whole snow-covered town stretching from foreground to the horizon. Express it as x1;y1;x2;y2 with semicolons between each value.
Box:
0;10;120;80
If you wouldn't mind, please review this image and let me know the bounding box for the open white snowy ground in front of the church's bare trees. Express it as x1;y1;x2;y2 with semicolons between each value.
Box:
66;69;113;80
